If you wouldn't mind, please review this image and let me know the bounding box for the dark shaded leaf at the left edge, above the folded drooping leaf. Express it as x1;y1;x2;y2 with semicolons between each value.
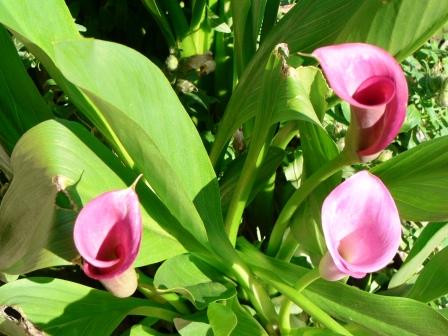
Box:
0;26;52;153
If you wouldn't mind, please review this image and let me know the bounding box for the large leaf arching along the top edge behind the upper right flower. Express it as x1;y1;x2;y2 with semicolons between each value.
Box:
211;0;448;162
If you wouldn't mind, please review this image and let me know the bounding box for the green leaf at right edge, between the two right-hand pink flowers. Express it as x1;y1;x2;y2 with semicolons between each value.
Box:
371;136;448;221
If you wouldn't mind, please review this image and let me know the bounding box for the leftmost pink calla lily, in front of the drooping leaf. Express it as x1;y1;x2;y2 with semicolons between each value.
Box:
74;187;142;297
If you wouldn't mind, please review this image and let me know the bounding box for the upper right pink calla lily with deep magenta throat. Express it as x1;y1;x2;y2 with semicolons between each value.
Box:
313;43;408;161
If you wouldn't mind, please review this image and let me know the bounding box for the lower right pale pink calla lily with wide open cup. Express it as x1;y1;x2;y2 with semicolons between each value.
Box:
319;171;401;280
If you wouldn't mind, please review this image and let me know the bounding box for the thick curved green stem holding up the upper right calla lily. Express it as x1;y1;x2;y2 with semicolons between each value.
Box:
267;151;356;256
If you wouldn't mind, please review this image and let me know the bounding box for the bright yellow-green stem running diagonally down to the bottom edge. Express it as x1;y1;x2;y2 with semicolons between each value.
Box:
263;277;353;336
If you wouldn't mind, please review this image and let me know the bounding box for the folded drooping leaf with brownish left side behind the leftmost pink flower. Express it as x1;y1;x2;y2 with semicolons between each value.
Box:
0;120;183;274
